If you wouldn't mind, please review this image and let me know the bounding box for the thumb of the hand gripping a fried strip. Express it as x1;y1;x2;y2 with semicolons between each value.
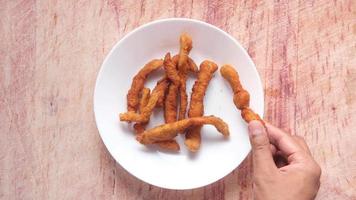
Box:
248;120;277;173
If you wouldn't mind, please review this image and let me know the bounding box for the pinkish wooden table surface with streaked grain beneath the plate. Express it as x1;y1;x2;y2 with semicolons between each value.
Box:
0;0;356;200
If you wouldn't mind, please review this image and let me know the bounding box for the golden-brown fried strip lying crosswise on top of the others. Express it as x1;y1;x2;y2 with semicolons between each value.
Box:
136;116;229;144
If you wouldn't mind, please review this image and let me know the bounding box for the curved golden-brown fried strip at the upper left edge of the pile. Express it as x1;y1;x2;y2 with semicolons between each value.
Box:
127;59;163;112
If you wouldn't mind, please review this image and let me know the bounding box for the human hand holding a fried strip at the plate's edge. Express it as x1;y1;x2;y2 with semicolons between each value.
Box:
248;121;321;200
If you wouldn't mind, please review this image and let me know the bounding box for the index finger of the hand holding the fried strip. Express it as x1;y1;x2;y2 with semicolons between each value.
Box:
266;123;304;162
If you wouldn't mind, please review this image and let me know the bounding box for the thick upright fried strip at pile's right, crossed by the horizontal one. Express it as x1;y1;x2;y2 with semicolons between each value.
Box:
184;60;218;152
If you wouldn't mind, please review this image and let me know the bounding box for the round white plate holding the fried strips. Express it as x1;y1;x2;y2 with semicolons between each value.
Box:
94;18;264;189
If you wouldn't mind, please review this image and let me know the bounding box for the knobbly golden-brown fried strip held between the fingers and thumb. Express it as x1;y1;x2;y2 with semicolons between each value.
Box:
220;65;264;124
